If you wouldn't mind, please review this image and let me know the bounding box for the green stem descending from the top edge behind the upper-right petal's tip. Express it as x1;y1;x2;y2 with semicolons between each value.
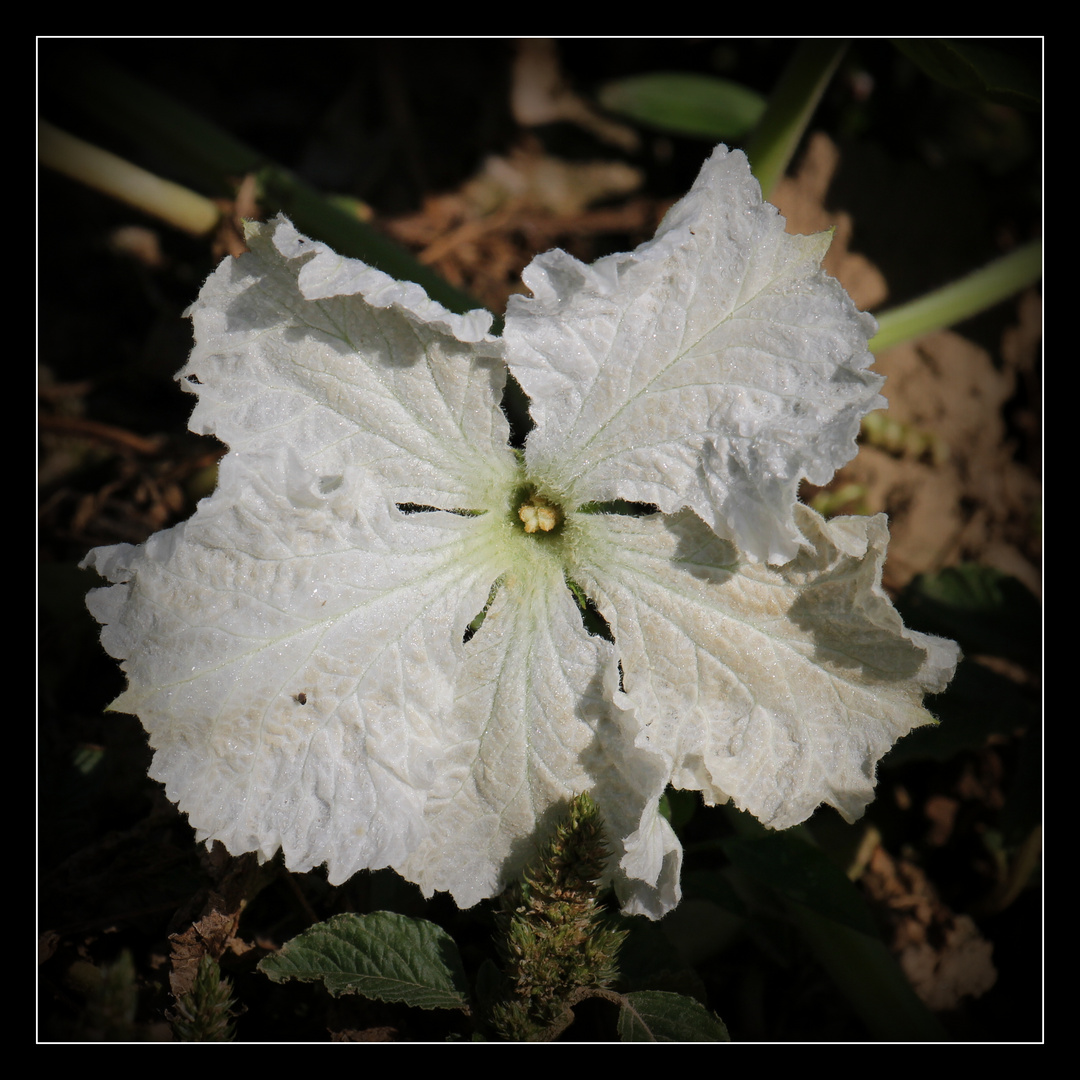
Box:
746;38;848;199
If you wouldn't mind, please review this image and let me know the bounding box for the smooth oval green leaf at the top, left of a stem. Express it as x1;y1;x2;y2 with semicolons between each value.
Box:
599;72;765;141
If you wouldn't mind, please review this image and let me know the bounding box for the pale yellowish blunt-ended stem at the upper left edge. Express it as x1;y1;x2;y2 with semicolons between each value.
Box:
38;120;221;237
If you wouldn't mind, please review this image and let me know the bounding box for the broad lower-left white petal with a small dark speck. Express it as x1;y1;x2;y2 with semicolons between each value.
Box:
85;476;505;883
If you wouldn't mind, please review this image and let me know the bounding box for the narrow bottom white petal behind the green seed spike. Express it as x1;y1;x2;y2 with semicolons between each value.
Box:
399;540;680;918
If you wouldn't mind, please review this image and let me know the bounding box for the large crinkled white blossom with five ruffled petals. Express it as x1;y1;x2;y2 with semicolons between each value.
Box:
85;147;958;917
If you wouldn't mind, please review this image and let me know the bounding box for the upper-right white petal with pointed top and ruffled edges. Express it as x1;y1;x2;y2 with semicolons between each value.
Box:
504;146;886;564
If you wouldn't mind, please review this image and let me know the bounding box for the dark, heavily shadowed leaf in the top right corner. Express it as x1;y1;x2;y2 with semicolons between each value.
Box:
894;39;1042;109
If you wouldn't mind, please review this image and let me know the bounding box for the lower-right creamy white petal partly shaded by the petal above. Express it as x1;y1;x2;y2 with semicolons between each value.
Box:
570;507;959;828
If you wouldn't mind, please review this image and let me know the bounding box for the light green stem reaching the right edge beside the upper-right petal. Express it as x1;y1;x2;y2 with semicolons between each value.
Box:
869;240;1042;353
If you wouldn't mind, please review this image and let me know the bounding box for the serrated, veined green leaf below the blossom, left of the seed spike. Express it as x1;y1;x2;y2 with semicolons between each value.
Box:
259;912;469;1012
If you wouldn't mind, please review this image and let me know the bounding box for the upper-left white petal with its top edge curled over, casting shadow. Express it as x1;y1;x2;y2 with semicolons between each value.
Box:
180;217;514;510
